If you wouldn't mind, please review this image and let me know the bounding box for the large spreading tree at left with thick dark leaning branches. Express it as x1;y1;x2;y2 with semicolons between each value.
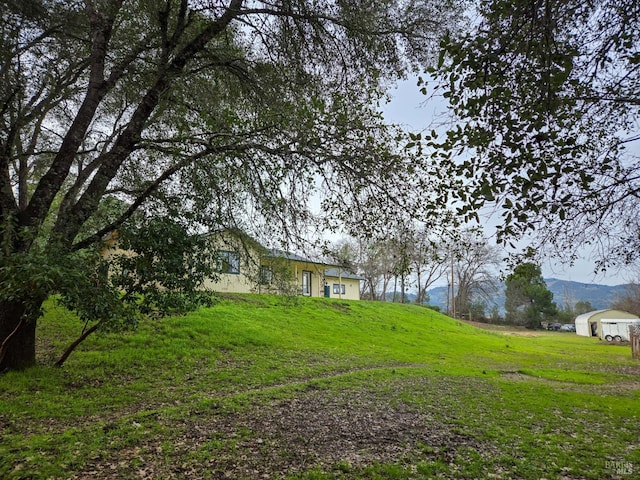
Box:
0;0;457;369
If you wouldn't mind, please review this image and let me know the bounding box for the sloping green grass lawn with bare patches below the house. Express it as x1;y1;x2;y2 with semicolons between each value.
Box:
0;295;640;479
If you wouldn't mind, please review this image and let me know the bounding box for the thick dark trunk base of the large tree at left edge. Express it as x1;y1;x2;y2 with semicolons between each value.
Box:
0;302;36;372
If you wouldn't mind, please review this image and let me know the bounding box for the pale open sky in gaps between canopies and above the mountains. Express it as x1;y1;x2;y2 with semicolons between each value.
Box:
382;78;636;285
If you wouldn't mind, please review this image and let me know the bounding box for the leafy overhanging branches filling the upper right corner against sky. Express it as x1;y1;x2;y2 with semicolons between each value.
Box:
431;0;640;268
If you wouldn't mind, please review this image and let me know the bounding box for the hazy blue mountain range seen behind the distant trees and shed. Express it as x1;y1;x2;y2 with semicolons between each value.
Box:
428;278;628;314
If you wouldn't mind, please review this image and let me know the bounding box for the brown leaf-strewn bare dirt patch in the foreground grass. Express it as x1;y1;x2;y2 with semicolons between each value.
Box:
229;391;459;470
